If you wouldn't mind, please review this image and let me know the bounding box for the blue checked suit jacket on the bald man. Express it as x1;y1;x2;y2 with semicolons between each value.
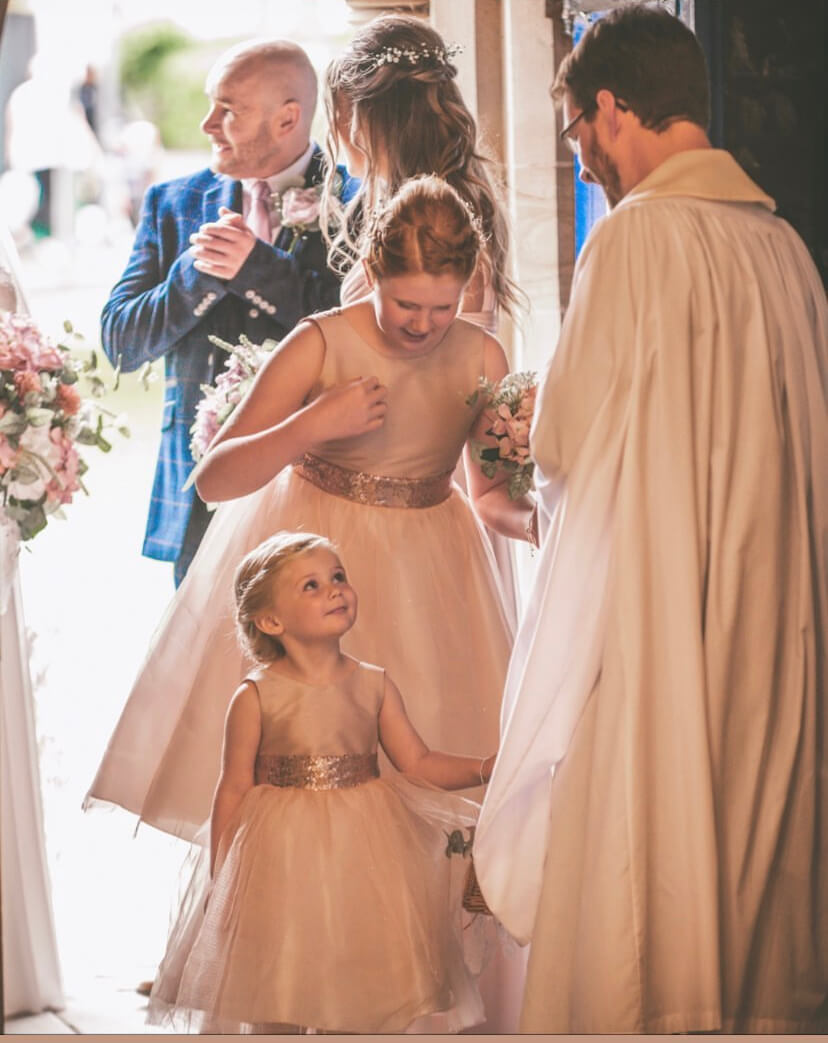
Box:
101;148;357;581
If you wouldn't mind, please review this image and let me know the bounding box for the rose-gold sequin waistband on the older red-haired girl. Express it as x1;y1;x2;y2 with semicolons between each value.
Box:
293;453;454;508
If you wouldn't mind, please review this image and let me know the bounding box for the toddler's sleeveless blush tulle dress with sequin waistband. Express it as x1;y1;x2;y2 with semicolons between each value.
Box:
149;661;483;1033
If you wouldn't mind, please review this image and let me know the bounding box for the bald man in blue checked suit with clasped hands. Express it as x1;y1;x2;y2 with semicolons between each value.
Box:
101;40;357;585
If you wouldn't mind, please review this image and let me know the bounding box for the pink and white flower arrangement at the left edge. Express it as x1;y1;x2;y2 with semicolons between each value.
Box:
0;311;129;540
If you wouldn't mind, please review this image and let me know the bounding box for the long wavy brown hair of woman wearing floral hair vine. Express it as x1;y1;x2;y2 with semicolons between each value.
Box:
321;15;522;314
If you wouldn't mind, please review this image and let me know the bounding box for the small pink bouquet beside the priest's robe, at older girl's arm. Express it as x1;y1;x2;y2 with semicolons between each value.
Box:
466;371;537;500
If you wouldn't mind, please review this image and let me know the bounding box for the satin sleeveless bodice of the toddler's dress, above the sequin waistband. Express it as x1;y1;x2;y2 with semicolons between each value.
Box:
250;663;385;757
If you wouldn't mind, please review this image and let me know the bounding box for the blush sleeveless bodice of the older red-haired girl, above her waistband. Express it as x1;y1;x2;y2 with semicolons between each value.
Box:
302;309;485;478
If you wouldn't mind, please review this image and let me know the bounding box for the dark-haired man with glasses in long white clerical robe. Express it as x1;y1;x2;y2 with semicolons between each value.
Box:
474;7;828;1033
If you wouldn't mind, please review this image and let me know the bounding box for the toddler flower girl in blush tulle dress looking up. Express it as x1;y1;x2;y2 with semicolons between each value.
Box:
150;532;494;1033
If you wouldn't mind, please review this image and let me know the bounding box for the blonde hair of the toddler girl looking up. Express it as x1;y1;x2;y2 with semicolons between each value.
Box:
234;532;338;664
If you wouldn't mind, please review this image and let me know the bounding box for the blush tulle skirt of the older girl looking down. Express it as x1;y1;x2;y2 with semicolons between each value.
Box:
89;469;513;839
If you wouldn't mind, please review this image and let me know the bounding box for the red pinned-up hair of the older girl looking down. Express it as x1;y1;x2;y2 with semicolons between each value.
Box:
365;174;485;282
